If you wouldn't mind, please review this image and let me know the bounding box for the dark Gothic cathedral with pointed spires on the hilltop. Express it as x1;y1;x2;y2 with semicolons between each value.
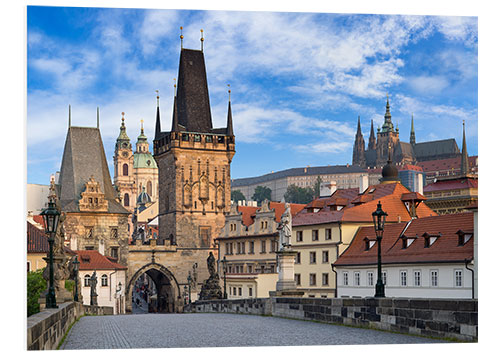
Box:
352;97;461;168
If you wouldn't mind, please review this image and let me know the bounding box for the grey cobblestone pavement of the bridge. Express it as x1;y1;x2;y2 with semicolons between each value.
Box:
61;313;444;350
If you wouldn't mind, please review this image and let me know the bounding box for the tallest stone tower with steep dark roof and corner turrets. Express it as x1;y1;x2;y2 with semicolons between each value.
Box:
154;49;235;248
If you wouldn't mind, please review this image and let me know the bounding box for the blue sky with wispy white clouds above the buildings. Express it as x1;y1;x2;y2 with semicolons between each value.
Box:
26;6;478;184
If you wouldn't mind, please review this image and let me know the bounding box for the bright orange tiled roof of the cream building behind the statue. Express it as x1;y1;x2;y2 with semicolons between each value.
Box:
292;182;436;226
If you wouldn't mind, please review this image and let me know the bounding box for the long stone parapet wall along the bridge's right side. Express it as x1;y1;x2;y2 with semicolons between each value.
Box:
191;297;478;341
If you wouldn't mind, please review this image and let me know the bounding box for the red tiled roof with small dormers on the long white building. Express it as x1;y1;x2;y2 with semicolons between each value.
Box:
334;212;474;266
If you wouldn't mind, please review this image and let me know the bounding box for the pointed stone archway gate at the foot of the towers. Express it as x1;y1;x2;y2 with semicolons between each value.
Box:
126;262;183;313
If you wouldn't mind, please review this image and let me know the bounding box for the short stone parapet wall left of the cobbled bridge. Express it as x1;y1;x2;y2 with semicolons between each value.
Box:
27;302;84;350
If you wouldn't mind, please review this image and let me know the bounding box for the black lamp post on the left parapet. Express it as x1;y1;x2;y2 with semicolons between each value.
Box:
40;200;61;309
